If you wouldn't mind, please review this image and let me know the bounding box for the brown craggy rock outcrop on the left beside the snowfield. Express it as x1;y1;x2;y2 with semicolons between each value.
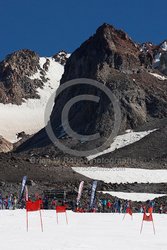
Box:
0;50;43;104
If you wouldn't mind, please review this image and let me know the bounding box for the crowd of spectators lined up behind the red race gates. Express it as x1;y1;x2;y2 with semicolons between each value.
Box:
0;193;167;213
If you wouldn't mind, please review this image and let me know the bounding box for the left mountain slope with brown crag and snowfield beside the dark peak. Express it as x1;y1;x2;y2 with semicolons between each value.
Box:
0;50;69;142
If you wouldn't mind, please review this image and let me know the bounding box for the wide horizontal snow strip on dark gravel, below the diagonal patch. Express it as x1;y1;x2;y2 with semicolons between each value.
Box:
73;167;167;183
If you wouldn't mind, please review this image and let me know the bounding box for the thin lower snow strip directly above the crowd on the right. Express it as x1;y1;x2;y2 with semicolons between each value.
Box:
102;191;167;201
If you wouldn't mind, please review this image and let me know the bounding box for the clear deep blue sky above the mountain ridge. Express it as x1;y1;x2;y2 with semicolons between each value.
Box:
0;0;167;59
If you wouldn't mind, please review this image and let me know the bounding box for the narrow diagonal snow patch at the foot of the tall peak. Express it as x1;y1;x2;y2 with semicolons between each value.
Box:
87;129;156;160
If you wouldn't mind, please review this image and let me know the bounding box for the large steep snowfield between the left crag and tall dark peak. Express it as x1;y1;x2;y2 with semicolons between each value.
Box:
0;57;64;142
